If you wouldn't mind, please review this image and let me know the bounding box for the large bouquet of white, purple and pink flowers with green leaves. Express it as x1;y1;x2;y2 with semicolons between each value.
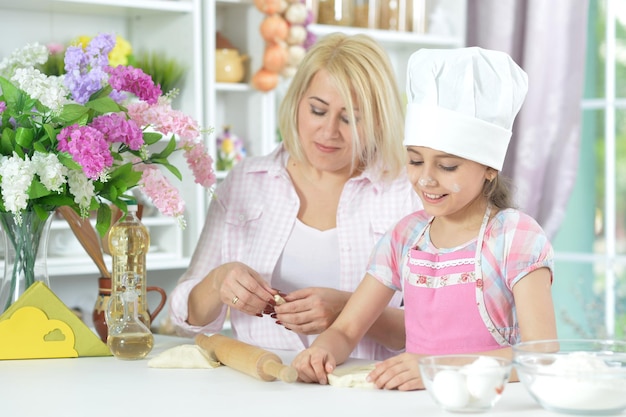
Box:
0;34;215;236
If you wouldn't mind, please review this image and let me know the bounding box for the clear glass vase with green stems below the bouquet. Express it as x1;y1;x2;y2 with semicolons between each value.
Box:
0;211;52;313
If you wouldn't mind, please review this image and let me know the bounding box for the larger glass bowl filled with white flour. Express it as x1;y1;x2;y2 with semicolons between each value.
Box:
513;339;626;415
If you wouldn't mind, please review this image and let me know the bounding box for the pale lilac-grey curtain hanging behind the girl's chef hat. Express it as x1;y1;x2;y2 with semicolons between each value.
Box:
467;0;588;237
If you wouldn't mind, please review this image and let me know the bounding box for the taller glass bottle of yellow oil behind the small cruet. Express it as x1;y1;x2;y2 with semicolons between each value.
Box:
108;200;151;328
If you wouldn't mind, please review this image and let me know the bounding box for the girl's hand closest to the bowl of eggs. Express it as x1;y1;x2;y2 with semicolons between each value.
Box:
368;353;424;391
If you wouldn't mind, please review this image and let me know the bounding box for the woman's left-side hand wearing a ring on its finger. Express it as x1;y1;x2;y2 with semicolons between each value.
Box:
216;262;277;316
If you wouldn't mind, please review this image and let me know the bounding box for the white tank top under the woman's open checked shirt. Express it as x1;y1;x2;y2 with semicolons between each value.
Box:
272;219;339;294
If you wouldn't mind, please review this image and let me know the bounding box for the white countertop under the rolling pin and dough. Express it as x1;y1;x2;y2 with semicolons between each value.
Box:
0;335;584;417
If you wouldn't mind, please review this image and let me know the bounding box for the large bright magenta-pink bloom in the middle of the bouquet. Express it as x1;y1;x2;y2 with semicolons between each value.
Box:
57;125;113;180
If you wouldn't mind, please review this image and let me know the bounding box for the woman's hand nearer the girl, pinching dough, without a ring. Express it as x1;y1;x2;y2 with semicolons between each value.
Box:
272;287;351;335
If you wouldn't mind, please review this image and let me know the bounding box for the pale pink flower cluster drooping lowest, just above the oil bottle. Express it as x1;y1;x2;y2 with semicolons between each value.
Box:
137;166;185;217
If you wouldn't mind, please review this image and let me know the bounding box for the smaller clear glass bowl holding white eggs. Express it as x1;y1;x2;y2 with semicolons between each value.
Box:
419;355;512;412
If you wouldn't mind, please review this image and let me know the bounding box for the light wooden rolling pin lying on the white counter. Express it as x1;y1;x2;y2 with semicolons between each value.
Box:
196;334;298;382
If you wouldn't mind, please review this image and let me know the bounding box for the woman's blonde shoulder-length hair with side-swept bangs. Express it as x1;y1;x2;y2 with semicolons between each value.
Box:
278;33;407;178
